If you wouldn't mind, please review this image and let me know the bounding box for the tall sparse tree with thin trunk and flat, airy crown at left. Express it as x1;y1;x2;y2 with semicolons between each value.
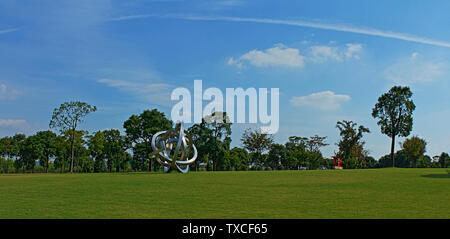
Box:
49;101;97;173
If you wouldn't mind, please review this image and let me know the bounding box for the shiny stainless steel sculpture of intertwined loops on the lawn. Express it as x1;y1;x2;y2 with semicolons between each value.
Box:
152;123;197;173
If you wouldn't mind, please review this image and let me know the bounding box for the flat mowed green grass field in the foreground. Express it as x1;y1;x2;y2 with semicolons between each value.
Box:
0;169;450;218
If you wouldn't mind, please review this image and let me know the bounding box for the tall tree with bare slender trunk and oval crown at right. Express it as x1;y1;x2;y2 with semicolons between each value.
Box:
372;86;416;167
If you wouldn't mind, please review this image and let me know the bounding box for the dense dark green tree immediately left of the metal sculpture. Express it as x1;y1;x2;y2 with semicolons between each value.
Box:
123;109;173;172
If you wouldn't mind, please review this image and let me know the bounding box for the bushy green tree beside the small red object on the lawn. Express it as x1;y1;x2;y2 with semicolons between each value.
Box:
336;120;370;168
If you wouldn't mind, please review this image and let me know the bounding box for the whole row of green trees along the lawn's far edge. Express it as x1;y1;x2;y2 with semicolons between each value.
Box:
0;86;450;173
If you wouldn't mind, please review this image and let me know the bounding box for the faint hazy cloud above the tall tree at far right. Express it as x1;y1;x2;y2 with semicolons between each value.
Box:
384;52;445;84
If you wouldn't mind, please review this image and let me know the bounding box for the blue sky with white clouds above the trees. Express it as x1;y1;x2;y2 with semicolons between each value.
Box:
0;0;450;158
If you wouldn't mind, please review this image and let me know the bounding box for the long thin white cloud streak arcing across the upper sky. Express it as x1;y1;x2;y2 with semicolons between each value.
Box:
110;14;450;47
